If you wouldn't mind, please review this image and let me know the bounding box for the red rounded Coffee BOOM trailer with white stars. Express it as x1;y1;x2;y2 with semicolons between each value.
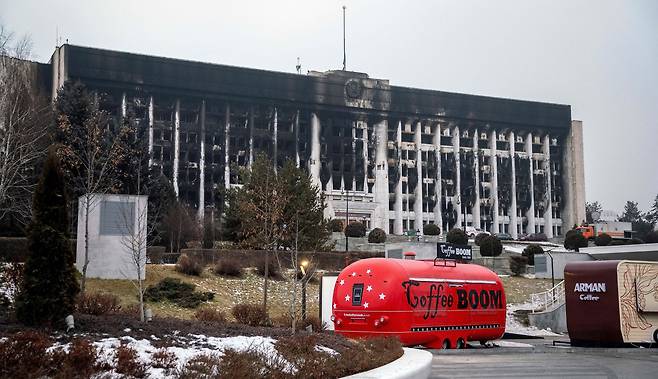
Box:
332;258;506;348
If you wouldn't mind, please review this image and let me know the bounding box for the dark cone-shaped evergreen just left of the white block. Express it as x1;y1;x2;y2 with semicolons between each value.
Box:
16;150;80;325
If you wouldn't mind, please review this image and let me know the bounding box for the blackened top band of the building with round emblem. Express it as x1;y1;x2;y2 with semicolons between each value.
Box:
55;45;571;131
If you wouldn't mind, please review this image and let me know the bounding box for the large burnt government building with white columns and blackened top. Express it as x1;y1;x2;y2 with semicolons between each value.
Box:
49;44;585;237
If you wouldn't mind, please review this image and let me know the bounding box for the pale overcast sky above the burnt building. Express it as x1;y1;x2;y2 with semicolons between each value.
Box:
0;0;658;211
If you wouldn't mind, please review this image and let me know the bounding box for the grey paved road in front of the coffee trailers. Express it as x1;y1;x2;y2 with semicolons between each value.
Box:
430;349;658;378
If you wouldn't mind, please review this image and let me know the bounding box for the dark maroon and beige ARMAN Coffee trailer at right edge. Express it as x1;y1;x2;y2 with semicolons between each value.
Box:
564;260;658;345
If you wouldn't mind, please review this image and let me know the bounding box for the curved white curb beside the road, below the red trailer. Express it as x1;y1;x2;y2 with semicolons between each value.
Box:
342;347;432;379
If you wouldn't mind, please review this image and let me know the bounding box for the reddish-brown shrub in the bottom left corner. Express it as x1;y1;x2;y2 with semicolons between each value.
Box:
0;330;51;378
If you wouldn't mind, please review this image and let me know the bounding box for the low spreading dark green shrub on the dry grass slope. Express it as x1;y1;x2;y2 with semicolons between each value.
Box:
144;278;215;308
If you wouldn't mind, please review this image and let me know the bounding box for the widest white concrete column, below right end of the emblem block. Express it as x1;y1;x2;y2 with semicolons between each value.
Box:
371;120;388;230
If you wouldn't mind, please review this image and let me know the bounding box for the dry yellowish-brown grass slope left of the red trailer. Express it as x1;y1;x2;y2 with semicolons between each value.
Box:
87;265;319;319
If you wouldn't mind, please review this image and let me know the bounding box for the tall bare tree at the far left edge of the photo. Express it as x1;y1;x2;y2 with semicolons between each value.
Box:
0;25;51;223
